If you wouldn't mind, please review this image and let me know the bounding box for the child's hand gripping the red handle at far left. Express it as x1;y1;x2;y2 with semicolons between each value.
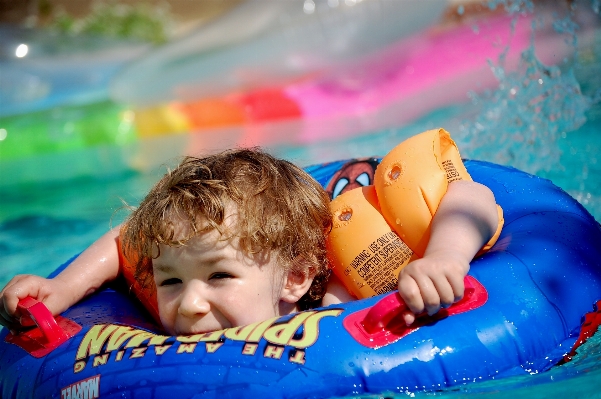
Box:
0;274;69;331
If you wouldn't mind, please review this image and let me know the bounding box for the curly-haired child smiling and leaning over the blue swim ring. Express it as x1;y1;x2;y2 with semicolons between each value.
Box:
0;145;497;335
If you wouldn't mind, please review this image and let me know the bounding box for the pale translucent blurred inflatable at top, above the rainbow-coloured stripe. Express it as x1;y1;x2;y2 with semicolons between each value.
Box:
110;0;448;105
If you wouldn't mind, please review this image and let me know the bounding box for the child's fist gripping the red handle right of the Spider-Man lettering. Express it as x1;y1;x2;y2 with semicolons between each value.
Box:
399;251;470;325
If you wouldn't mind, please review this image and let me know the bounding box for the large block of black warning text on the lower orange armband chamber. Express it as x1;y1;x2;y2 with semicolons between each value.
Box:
351;231;413;294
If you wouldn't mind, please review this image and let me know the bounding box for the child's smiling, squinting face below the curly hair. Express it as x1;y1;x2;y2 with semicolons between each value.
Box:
153;220;292;335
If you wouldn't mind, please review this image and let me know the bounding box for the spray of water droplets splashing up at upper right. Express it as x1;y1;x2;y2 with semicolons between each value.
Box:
461;0;598;173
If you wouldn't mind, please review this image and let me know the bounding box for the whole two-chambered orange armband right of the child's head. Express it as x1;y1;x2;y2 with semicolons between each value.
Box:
328;129;503;298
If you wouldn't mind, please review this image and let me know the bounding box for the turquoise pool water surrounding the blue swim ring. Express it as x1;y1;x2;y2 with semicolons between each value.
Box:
0;0;601;399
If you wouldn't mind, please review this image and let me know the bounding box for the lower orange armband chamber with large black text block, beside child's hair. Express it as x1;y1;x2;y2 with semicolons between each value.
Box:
327;186;413;298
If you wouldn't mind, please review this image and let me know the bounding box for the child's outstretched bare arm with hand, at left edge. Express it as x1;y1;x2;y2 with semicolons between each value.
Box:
0;226;120;329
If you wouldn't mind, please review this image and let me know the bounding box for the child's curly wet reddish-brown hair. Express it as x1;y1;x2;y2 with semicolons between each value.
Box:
120;148;332;309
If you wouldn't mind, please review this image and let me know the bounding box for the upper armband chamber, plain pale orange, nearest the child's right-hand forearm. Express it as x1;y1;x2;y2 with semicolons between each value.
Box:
374;129;472;257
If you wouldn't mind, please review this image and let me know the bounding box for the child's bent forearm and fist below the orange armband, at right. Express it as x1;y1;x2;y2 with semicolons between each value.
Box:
399;180;498;325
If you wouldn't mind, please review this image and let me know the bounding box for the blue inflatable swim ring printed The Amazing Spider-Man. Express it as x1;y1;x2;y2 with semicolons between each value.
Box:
0;159;601;399
